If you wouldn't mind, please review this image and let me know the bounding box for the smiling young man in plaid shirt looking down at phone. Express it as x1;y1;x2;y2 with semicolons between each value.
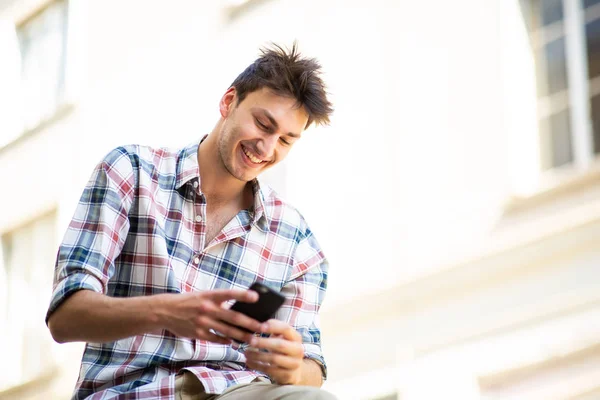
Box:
46;45;332;400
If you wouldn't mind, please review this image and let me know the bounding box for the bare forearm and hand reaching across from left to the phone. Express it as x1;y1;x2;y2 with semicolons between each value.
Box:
48;289;260;344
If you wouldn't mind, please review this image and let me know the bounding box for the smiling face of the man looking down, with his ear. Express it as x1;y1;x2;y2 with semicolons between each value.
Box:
218;88;308;182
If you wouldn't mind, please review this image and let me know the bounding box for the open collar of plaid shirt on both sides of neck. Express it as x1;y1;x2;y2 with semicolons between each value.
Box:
175;135;270;230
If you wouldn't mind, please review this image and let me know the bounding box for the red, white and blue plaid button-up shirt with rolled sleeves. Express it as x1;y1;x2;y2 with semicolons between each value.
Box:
46;139;328;399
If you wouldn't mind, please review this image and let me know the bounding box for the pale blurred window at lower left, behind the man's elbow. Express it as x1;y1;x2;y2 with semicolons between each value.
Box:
0;213;57;390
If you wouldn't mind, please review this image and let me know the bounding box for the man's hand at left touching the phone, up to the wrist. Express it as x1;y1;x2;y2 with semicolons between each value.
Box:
156;289;261;344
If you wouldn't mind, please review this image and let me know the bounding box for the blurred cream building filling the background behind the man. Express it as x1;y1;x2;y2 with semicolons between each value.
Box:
0;0;600;400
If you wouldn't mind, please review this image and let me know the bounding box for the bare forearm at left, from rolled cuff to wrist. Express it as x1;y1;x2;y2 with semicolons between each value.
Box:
48;290;166;343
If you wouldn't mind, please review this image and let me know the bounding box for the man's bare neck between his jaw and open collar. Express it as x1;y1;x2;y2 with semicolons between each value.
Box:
198;125;252;204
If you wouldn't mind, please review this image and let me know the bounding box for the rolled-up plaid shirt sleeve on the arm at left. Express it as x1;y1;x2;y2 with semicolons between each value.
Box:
46;147;135;323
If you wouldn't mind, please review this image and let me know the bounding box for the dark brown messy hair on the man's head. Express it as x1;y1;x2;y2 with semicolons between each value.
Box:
231;42;333;129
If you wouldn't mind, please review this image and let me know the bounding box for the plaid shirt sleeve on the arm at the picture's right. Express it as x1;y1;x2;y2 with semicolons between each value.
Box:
276;225;329;380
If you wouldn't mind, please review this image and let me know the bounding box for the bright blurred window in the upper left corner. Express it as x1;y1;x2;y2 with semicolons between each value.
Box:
0;0;67;146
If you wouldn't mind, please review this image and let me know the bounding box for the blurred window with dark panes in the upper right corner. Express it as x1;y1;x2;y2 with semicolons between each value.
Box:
521;0;600;170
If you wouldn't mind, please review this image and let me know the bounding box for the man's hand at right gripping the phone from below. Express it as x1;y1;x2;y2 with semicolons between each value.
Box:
245;319;304;385
